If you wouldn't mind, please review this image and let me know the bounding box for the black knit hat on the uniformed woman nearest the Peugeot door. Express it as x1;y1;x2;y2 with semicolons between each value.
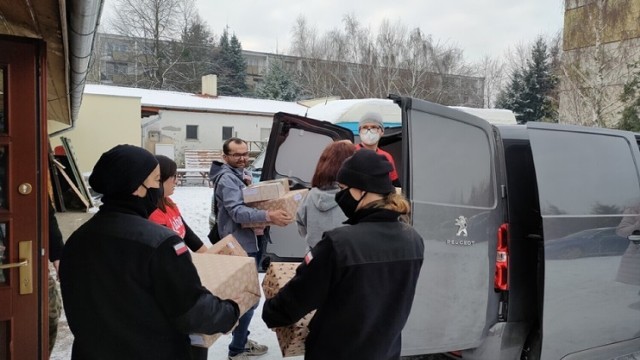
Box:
336;149;396;194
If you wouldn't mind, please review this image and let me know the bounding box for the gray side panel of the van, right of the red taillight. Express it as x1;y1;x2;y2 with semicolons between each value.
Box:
527;122;640;359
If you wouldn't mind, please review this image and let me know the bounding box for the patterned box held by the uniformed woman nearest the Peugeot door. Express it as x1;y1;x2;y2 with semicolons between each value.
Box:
262;262;315;357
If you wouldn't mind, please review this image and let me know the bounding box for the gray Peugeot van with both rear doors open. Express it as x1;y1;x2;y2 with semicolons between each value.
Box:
262;97;640;360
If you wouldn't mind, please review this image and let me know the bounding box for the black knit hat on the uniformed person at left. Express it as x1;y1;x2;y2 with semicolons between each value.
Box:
89;145;158;196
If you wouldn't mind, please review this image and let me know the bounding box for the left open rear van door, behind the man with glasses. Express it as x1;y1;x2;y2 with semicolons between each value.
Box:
260;113;353;260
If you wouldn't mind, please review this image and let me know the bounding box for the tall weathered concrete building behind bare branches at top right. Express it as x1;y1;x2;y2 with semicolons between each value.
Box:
560;0;640;127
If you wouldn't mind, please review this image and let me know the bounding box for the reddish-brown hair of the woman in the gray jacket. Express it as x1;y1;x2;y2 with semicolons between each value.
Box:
311;140;356;189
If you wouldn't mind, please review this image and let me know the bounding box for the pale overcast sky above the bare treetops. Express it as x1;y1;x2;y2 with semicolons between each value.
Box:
197;0;564;61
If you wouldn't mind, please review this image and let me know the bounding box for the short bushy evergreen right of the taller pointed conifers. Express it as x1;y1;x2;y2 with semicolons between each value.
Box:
256;59;300;101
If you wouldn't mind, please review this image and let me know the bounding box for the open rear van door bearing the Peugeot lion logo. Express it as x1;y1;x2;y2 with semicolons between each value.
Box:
390;98;505;355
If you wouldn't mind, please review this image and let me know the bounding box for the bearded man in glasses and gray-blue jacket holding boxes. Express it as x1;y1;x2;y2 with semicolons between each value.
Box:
213;138;293;360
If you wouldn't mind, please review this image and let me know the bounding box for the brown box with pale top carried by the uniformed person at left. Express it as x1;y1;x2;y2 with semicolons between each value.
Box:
191;253;261;347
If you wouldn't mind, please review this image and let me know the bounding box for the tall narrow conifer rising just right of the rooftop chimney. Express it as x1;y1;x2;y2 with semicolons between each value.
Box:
215;29;247;96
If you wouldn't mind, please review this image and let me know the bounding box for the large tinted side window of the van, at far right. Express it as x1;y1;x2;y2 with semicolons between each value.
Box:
529;129;640;215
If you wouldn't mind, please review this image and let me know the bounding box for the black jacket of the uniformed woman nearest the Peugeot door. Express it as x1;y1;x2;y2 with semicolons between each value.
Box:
262;209;424;360
